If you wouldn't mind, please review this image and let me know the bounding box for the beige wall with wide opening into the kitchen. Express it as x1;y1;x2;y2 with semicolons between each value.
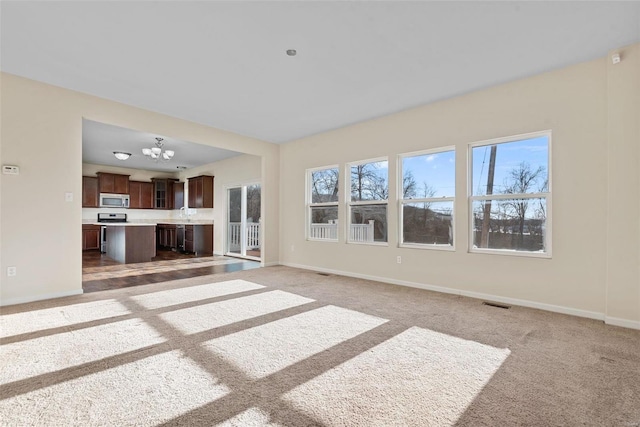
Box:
0;73;279;304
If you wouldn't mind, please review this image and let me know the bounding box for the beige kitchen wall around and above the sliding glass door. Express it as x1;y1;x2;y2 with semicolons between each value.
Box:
179;154;262;256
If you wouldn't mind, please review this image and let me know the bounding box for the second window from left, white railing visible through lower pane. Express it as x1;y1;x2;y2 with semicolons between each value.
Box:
348;159;389;243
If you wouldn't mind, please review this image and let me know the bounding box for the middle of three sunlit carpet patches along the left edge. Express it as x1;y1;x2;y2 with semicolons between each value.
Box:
0;319;165;384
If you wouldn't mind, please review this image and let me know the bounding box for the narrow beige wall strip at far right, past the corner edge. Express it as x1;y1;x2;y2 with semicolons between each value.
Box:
606;44;640;324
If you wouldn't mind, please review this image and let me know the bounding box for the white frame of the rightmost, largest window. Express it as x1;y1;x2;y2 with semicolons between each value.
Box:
467;129;553;259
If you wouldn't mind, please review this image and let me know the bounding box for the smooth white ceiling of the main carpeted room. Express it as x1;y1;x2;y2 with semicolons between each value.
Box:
0;1;640;143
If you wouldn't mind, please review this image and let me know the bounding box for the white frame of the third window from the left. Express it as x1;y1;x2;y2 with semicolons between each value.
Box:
396;145;458;252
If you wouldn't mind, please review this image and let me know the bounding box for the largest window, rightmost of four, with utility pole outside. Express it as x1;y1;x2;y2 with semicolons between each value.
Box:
469;132;551;257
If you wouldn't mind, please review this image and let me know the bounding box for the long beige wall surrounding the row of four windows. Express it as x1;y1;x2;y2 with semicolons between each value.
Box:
280;46;640;327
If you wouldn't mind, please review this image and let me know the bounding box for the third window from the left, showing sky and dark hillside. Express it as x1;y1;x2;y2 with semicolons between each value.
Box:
398;148;456;249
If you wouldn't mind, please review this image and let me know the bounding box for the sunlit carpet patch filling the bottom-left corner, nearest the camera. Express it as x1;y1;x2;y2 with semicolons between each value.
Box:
0;350;229;426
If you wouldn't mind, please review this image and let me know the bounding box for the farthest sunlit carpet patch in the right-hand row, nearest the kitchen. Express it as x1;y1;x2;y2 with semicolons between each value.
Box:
131;279;264;310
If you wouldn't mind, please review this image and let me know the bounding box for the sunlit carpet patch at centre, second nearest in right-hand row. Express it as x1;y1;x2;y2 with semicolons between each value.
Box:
202;306;387;379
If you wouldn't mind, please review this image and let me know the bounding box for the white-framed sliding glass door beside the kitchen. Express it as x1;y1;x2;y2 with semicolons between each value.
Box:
226;184;262;261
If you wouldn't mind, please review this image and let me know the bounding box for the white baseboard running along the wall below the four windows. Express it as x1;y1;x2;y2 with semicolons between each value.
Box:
282;263;608;327
